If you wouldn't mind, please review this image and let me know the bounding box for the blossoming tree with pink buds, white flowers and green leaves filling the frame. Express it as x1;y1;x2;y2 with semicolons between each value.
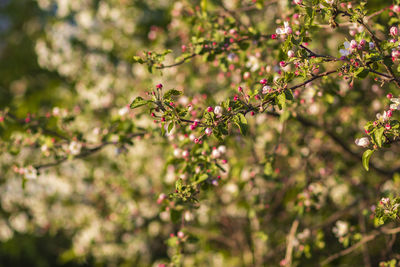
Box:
0;0;400;266
